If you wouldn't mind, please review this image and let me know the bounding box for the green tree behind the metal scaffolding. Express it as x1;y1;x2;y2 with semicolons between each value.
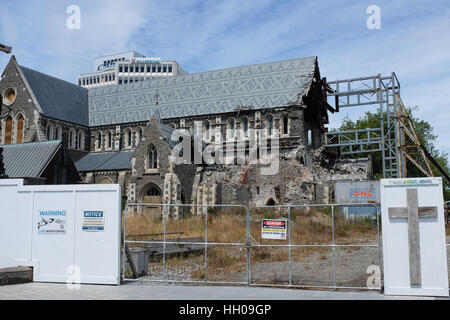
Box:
336;106;450;201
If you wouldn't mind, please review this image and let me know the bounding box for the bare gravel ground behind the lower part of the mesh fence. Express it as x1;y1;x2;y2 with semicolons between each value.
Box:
129;236;450;288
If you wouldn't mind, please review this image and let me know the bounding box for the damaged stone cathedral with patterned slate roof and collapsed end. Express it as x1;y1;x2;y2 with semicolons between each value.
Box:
0;56;372;216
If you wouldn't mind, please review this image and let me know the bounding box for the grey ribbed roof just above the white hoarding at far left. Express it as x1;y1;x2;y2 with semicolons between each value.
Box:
0;140;61;178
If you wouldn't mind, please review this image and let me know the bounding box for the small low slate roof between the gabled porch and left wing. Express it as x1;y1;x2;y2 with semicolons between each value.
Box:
75;150;134;172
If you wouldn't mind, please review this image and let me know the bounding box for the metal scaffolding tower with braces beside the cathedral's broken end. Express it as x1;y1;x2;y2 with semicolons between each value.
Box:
324;73;442;179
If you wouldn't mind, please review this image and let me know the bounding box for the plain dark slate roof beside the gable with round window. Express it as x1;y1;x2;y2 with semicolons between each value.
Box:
19;66;89;126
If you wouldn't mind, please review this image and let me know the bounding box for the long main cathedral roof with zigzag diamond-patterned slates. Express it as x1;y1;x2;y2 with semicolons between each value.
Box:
89;57;317;126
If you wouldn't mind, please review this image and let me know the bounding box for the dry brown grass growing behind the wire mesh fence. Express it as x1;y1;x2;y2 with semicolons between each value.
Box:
126;210;377;279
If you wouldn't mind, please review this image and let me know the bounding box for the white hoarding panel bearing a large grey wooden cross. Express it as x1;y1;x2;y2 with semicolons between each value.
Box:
381;178;449;296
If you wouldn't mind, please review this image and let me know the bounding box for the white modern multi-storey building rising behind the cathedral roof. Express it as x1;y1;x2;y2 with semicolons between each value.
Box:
78;51;187;88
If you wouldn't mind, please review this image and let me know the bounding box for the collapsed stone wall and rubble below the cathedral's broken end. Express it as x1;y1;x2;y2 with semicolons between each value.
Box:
193;146;371;206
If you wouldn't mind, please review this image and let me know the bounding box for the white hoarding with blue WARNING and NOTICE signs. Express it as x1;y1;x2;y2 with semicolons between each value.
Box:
0;179;121;284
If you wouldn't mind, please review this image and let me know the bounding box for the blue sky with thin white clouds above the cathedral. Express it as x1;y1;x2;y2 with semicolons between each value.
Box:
0;0;450;158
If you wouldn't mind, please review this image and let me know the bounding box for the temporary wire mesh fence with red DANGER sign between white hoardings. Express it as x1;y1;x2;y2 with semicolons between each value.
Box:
122;203;381;290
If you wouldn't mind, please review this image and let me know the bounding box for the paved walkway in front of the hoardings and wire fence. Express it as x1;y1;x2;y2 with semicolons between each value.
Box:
0;282;442;300
